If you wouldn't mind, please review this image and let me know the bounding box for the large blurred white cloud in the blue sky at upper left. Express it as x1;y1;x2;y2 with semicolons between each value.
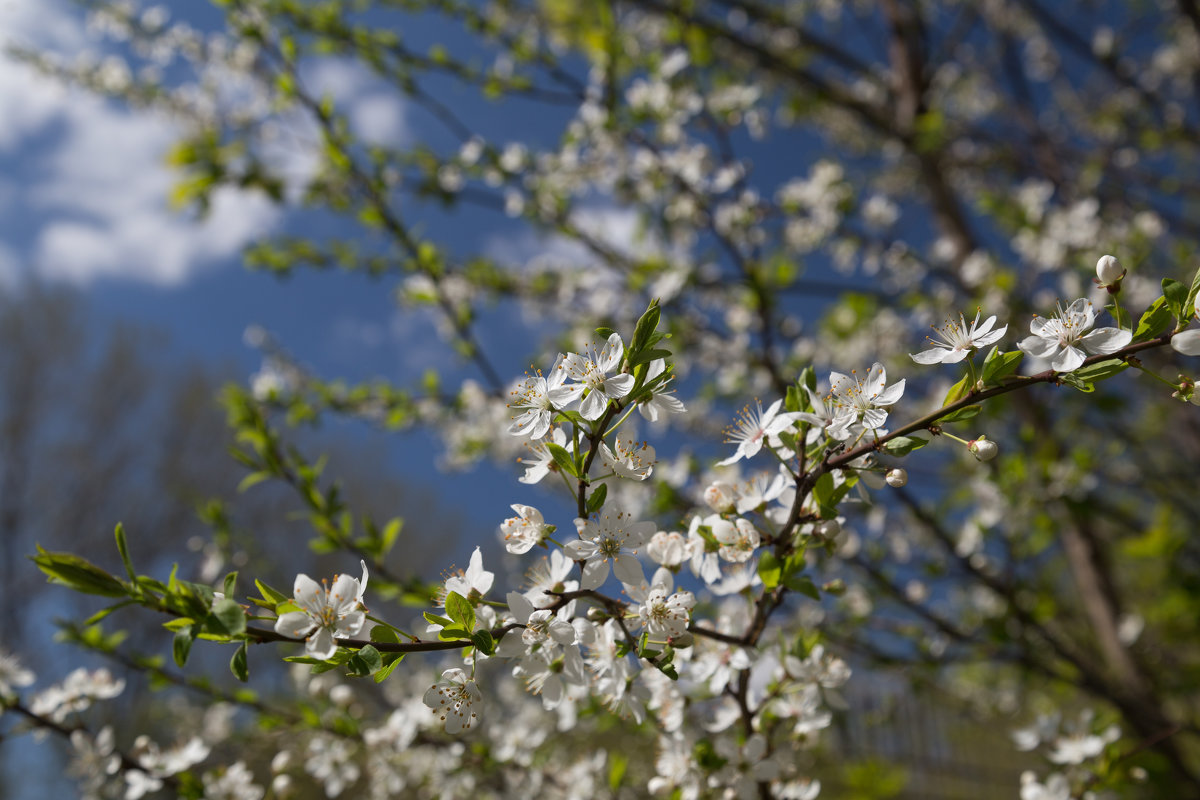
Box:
0;0;281;285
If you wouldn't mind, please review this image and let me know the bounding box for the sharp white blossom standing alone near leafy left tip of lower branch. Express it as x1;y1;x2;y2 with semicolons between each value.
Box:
275;566;367;661
